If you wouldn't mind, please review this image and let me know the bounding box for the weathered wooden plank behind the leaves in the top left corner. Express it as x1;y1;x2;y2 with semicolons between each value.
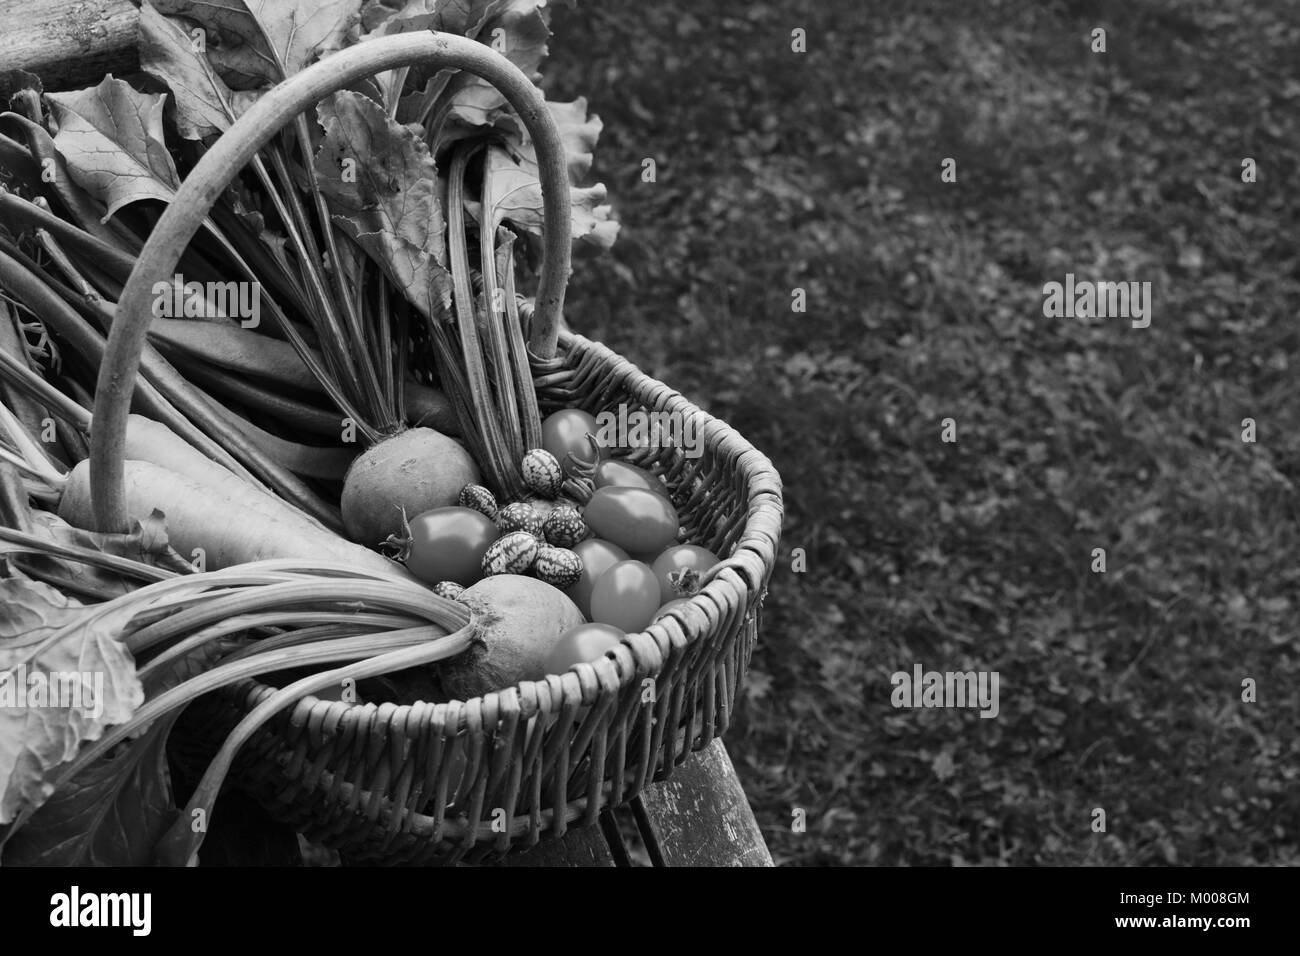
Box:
0;0;139;90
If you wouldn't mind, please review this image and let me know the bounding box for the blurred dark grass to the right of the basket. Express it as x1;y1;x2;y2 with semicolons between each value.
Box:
546;0;1300;865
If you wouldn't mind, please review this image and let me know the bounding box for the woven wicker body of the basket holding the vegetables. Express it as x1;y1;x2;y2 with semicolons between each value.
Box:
92;34;781;864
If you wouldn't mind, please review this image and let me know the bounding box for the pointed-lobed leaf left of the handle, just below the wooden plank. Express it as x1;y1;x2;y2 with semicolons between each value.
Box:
46;74;181;222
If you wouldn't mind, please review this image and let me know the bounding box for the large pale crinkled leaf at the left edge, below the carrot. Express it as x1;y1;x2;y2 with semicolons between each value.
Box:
0;575;144;825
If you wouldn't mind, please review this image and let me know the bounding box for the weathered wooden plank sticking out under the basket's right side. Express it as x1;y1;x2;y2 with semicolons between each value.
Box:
633;740;772;866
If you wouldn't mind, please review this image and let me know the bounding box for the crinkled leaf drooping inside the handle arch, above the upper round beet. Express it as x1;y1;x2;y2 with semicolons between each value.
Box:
315;91;451;317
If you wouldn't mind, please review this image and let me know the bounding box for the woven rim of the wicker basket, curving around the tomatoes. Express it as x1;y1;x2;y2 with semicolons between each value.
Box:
231;330;783;739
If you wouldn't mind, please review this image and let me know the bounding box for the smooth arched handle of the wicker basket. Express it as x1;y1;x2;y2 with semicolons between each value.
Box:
90;31;572;532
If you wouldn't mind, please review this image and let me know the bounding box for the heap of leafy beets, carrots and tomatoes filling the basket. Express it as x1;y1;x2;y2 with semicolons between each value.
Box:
0;0;733;865
